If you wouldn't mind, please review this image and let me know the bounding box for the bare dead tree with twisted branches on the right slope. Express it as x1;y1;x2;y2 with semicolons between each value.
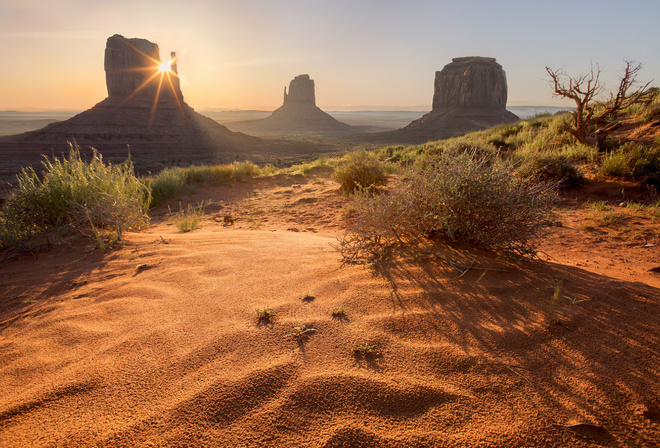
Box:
545;61;650;147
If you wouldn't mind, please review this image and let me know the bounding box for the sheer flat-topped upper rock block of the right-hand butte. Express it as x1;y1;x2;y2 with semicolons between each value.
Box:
433;56;507;110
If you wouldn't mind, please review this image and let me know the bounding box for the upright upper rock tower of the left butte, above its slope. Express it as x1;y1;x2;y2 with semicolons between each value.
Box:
104;34;183;99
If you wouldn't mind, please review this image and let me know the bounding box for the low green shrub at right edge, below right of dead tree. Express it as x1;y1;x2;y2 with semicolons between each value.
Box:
600;142;660;187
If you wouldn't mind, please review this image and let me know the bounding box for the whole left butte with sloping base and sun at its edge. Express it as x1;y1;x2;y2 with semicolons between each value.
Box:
0;35;262;174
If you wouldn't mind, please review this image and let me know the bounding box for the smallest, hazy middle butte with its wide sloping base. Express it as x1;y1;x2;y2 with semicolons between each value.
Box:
228;75;360;134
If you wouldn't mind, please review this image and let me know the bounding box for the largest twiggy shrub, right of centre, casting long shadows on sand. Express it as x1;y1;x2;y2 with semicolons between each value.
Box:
338;151;556;260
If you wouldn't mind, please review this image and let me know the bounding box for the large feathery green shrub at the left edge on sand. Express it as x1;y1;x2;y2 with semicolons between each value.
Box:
0;145;151;247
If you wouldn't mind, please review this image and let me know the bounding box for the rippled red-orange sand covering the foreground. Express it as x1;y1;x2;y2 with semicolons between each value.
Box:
0;171;660;447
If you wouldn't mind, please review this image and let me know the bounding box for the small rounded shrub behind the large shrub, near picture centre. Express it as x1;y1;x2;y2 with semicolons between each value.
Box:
333;151;387;191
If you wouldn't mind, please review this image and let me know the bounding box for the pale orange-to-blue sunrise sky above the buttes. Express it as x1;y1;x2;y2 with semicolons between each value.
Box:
0;0;660;110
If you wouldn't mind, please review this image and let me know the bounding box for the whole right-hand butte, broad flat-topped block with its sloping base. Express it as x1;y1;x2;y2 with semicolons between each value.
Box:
404;56;518;139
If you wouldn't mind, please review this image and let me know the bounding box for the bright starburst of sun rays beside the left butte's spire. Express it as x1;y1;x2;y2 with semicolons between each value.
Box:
115;40;185;128
